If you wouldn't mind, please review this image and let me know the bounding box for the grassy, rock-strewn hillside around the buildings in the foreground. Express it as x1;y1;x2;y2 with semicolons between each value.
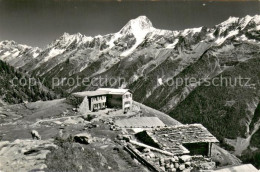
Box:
0;99;240;172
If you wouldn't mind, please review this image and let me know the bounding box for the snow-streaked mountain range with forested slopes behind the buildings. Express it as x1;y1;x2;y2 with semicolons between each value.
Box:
0;15;260;165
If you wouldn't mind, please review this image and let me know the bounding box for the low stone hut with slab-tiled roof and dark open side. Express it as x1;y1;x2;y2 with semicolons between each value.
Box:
136;124;218;157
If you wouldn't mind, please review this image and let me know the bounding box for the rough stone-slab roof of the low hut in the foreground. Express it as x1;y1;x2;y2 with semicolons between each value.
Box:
136;124;218;155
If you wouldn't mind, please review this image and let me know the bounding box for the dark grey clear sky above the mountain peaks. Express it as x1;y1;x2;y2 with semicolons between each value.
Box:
0;0;260;48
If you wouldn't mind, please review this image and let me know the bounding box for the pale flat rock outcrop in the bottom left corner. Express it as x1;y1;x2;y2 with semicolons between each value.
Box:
0;140;56;172
